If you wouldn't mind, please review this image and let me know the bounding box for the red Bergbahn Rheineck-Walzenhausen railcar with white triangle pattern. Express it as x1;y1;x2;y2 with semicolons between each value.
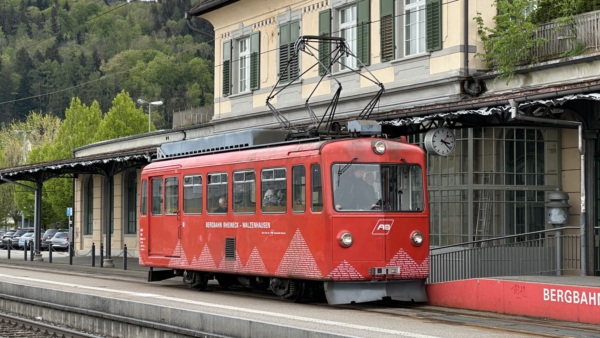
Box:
139;127;429;304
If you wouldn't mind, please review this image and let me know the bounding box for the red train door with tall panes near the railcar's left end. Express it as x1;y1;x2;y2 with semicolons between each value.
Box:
148;176;181;257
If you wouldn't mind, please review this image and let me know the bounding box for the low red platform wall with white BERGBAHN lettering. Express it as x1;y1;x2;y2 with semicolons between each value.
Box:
426;276;600;324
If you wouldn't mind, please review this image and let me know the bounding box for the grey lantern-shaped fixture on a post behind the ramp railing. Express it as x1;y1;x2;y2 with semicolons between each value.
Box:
546;189;571;276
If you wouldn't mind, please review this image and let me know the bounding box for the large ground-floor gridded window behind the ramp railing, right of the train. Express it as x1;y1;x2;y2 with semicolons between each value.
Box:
427;127;560;246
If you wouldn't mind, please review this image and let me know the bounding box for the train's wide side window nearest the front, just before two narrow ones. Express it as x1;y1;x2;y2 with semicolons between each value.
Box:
261;168;287;213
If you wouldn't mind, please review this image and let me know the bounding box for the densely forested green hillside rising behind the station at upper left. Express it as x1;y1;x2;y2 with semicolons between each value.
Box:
0;0;213;129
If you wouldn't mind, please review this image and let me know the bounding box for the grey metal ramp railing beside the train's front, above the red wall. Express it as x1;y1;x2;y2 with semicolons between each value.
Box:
427;227;581;283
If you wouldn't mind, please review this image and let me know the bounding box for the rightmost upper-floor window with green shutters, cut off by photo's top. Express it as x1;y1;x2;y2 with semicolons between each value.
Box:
380;0;442;61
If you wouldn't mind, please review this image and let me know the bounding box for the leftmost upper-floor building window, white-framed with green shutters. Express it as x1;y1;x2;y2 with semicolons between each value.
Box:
222;32;260;96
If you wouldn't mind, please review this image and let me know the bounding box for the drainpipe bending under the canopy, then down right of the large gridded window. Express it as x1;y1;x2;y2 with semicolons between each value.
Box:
508;99;587;276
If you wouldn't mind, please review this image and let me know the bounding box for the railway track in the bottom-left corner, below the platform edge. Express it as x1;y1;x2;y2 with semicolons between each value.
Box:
0;313;102;338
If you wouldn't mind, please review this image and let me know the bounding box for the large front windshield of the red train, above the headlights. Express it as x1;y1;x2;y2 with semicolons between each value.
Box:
331;162;425;212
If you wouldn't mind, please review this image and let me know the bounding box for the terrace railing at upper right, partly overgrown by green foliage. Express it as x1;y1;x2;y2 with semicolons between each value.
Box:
527;11;600;62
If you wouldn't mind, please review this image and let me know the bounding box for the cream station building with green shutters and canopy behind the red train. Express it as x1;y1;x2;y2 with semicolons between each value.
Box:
2;0;600;275
